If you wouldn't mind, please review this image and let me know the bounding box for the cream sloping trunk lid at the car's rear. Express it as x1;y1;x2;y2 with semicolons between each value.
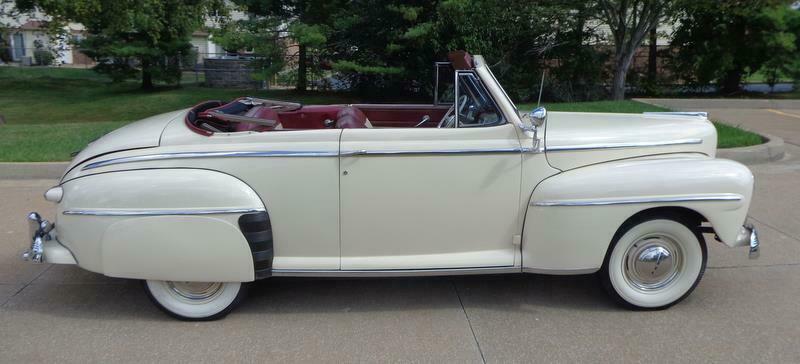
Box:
62;111;182;178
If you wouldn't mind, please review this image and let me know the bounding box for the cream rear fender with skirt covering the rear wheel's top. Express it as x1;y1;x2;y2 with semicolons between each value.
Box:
56;169;266;282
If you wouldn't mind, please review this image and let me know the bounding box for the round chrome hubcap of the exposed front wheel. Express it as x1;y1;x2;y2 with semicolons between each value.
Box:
623;235;683;291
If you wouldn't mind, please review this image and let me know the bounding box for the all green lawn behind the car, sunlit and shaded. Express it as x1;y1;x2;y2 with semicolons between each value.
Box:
0;67;762;162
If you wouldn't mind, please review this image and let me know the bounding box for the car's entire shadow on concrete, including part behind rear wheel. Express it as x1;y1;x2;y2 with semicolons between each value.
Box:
2;267;623;321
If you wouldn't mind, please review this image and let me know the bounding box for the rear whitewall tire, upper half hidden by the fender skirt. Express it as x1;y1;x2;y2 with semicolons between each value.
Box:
143;280;247;321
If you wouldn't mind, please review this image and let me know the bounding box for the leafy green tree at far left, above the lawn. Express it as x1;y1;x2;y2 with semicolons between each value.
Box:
17;0;221;89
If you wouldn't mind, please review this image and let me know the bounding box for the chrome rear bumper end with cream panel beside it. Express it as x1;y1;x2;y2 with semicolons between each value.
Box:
21;212;77;264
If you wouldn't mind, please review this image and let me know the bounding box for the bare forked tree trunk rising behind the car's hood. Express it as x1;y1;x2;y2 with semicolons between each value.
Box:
597;0;672;100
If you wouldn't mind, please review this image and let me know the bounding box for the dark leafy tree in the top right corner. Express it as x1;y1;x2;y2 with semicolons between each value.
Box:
672;0;800;94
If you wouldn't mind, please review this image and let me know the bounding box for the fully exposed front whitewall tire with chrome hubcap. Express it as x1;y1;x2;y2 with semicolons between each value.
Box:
600;216;707;309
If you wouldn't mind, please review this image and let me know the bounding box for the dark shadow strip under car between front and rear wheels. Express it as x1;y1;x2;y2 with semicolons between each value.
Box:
238;274;622;313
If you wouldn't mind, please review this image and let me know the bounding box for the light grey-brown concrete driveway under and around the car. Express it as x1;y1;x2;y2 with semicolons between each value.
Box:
0;98;800;363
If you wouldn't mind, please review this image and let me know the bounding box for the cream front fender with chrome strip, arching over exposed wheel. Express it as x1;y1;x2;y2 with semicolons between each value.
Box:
522;156;753;273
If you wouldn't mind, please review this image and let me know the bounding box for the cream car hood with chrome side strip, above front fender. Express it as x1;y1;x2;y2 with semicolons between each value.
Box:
545;112;717;170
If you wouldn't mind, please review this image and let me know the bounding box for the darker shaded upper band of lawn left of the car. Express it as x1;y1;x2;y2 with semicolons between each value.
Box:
0;67;353;124
